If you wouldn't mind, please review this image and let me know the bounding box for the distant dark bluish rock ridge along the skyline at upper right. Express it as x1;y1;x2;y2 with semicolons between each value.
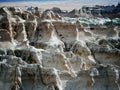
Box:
51;2;120;18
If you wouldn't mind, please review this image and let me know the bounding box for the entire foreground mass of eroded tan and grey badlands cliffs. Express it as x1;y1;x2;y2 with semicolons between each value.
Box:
0;7;120;90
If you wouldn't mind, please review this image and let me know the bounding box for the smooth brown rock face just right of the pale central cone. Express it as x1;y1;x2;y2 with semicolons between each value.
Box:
54;22;78;43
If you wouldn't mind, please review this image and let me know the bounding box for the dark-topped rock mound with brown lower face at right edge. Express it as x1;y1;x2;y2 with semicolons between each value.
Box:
88;39;120;66
